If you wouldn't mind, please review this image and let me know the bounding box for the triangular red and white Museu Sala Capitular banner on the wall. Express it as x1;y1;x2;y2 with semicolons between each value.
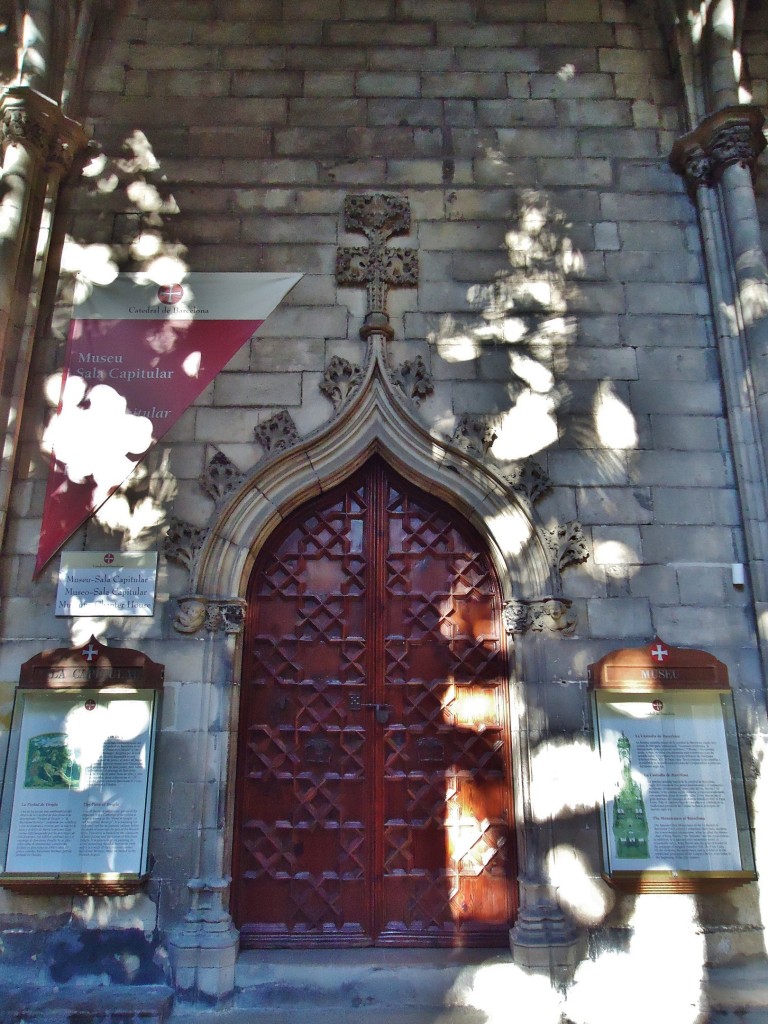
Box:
35;273;301;575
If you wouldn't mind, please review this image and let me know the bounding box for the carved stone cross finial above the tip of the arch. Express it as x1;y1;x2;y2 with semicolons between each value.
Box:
336;193;419;338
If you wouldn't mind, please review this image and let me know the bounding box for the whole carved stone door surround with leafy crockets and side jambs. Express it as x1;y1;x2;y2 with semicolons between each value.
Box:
166;334;587;999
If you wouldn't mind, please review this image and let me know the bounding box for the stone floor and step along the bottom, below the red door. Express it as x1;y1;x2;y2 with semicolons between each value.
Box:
0;950;768;1024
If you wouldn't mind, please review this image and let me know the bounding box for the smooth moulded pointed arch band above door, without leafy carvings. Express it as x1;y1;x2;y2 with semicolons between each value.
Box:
190;337;560;601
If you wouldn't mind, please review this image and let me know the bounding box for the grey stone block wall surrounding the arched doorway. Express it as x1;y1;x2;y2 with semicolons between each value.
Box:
0;0;762;974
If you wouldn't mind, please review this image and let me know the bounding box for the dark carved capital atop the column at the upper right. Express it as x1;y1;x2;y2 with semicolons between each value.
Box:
670;103;766;194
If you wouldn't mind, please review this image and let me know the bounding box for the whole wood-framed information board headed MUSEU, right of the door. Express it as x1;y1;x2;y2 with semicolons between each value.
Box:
590;638;757;892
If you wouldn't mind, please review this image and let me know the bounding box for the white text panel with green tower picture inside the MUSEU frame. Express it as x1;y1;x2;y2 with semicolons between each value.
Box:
595;689;744;874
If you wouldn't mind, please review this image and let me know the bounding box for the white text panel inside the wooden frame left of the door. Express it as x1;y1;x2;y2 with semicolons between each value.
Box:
3;689;157;878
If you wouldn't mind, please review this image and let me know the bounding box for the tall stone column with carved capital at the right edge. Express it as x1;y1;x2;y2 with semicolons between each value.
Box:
670;105;768;655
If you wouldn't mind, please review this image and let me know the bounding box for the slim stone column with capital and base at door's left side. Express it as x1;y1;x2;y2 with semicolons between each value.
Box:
169;595;245;1008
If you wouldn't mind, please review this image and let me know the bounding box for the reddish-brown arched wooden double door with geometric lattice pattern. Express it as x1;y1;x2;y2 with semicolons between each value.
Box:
232;460;516;946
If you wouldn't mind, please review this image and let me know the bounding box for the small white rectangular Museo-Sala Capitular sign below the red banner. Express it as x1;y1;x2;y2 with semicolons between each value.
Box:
56;551;158;615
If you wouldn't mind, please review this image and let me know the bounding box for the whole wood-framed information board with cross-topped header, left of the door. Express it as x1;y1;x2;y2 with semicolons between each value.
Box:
0;638;162;894
